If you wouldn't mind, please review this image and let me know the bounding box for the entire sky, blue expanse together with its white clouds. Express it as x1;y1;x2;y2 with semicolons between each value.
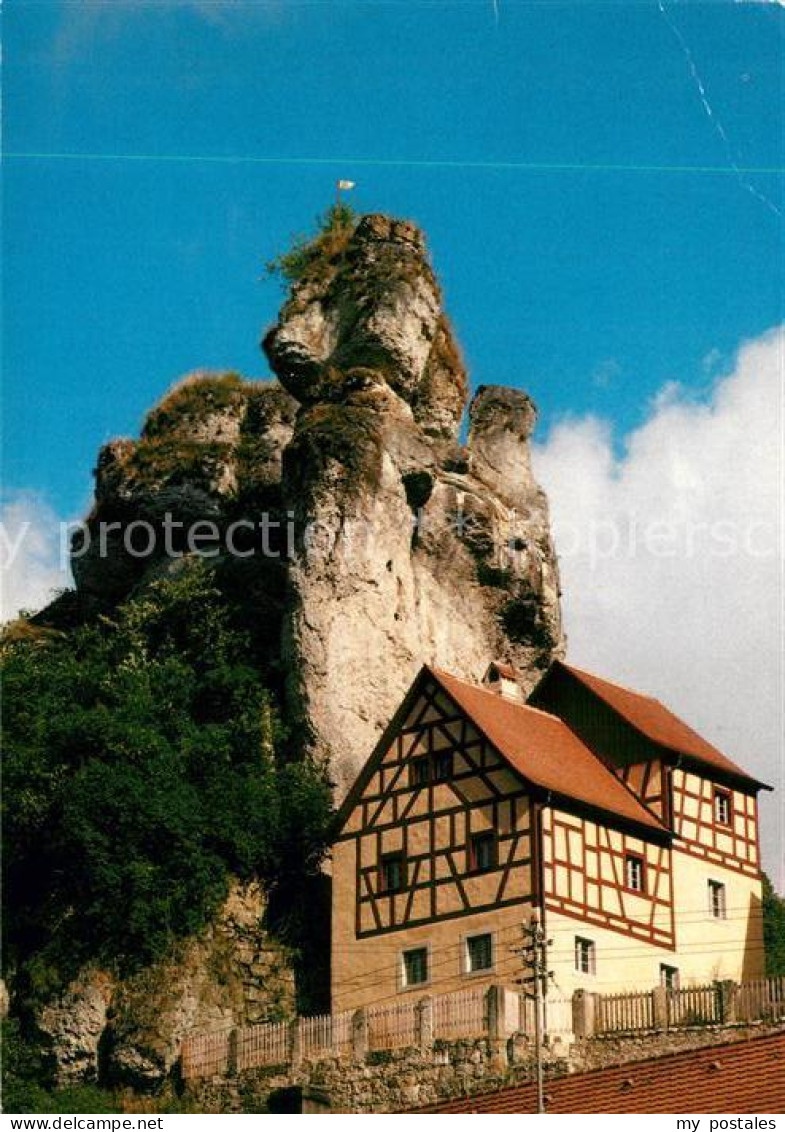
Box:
0;0;785;889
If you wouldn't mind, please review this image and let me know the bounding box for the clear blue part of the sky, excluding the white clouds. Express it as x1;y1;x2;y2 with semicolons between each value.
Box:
3;0;785;514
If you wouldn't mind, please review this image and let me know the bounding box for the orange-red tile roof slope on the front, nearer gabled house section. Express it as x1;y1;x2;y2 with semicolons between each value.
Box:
428;668;666;833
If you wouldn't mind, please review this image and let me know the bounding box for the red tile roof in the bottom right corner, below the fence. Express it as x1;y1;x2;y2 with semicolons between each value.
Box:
419;1031;785;1115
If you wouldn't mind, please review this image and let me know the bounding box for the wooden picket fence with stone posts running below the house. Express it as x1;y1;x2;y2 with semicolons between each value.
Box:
181;978;785;1078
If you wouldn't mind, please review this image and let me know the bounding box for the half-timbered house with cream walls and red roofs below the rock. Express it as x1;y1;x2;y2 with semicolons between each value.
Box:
332;664;762;1011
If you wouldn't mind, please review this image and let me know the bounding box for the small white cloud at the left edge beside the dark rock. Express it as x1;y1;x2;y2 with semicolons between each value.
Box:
0;491;70;621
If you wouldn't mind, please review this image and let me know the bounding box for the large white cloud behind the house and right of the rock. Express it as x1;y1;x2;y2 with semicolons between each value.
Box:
535;327;785;887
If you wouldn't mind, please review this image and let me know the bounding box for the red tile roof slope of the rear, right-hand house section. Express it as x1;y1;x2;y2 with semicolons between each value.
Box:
554;661;762;786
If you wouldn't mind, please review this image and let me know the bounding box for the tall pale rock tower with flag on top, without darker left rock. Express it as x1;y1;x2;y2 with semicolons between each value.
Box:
264;215;563;795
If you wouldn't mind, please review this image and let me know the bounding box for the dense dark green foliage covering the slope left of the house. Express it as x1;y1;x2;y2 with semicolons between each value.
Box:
2;563;330;995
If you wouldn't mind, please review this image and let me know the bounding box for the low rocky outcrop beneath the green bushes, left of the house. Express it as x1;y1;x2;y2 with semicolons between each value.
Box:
36;883;295;1092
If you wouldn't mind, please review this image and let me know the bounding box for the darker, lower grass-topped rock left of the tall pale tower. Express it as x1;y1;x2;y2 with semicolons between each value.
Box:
71;372;297;604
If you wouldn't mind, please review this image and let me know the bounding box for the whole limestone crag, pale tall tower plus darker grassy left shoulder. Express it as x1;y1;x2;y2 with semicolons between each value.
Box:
52;215;563;797
